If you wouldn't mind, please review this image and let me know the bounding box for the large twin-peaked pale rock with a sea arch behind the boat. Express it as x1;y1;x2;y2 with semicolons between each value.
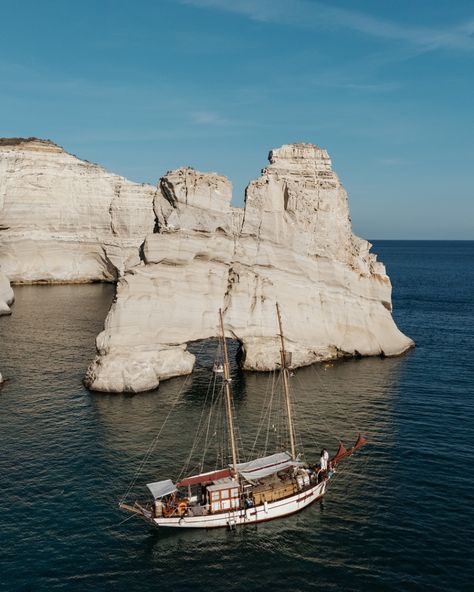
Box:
85;144;413;392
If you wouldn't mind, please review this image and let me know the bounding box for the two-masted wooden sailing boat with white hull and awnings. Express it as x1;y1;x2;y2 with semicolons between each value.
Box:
119;303;366;528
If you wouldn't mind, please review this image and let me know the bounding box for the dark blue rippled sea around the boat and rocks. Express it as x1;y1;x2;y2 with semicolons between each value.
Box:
0;241;474;592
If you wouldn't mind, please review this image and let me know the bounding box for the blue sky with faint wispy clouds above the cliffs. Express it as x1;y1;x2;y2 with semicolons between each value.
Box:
0;0;474;240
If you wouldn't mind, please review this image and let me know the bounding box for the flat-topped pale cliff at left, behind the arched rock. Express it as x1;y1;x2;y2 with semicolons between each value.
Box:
0;138;157;283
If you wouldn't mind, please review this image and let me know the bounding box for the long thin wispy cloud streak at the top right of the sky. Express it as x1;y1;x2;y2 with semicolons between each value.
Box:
181;0;474;51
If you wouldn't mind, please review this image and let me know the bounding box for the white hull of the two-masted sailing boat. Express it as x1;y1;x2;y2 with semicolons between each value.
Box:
146;481;327;528
